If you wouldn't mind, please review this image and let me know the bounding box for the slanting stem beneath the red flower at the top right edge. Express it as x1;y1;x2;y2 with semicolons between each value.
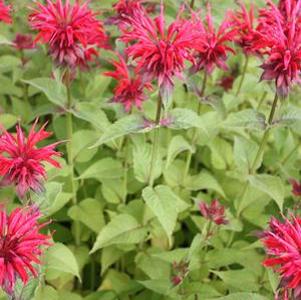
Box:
237;92;278;217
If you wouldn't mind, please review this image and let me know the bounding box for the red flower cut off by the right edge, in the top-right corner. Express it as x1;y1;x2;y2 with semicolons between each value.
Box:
259;0;301;97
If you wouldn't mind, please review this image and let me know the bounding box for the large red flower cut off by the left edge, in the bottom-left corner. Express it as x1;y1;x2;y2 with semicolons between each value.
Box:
0;206;50;294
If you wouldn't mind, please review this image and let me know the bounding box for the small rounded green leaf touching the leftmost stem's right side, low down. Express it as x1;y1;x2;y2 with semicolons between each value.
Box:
68;198;105;233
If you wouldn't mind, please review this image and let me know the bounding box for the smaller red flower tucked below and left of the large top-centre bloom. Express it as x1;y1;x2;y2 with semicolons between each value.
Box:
105;55;152;112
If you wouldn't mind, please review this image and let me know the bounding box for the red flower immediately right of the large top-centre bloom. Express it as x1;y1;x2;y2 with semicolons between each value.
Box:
191;4;237;74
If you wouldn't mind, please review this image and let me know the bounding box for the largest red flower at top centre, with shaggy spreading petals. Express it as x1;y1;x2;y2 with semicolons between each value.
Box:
121;5;201;98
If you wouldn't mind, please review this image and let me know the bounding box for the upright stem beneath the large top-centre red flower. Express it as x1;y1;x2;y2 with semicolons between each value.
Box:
148;93;162;187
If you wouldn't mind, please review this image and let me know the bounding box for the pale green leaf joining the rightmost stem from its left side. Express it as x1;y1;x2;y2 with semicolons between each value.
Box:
222;109;266;130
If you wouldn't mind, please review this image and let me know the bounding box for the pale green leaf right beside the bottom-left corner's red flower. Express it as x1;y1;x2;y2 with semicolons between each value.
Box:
45;243;80;279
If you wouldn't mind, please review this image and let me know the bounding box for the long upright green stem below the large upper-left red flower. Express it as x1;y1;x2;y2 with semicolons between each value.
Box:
65;70;80;246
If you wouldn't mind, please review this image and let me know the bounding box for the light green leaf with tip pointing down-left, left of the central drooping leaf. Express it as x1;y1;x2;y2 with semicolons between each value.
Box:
91;214;146;253
